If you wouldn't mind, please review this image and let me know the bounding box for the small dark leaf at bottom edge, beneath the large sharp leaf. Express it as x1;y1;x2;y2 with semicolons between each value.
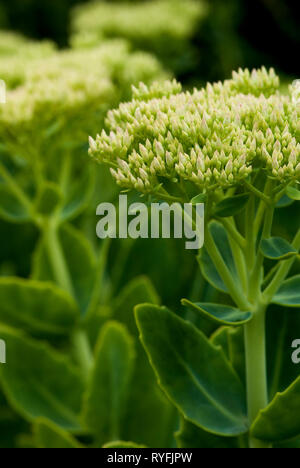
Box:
175;418;238;449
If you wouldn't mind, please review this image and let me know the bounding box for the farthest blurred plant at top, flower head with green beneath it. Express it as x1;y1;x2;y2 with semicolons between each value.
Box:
71;0;207;73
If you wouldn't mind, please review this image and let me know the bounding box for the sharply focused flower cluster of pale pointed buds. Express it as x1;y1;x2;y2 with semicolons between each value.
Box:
90;68;300;193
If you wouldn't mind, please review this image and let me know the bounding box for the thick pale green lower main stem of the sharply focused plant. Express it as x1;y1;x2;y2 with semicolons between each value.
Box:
245;305;269;448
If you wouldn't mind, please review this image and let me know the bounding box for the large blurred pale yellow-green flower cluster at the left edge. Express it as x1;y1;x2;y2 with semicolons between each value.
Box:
0;40;166;150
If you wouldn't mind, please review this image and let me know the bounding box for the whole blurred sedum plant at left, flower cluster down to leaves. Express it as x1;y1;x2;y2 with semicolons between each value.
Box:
0;33;178;448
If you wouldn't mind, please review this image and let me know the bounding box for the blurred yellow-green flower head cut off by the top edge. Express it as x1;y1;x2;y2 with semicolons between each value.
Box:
73;0;206;50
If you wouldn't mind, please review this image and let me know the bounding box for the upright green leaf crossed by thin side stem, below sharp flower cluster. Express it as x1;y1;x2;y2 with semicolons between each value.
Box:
198;221;240;293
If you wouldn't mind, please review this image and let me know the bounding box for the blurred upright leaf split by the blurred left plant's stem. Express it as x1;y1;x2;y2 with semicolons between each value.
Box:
33;225;97;315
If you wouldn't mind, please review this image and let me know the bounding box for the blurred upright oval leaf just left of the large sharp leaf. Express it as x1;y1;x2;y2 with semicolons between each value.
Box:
83;322;135;444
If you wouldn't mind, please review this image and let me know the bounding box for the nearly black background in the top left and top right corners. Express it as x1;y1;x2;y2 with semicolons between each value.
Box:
0;0;300;81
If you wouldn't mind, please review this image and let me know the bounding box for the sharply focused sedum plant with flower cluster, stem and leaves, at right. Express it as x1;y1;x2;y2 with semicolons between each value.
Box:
90;68;300;448
